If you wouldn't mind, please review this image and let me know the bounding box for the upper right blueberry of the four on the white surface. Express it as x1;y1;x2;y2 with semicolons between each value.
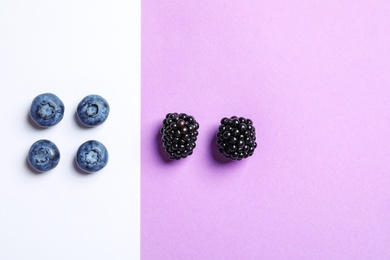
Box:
77;95;110;127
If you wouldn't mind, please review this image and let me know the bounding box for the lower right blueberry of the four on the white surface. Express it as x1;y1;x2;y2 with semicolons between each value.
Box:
76;140;108;173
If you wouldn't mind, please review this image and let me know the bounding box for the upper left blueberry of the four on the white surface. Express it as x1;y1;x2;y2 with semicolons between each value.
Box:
29;93;65;128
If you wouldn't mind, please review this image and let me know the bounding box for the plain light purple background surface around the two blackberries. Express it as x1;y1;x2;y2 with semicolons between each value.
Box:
141;0;390;260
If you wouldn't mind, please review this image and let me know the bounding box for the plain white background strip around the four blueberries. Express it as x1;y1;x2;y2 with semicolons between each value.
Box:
0;0;141;260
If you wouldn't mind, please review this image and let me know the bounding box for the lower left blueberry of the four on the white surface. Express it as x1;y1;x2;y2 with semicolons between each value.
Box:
27;140;60;172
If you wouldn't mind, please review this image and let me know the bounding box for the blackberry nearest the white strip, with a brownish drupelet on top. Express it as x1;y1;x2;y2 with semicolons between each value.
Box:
160;113;199;160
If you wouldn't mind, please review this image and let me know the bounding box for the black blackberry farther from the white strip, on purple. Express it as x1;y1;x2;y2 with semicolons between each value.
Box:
217;116;257;160
